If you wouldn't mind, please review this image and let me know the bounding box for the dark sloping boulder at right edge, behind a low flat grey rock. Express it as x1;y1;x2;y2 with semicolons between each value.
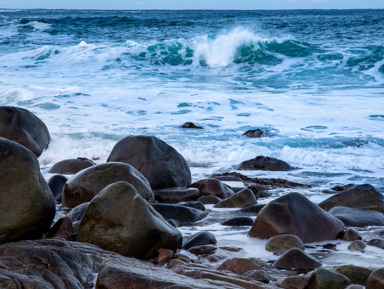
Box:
319;184;384;213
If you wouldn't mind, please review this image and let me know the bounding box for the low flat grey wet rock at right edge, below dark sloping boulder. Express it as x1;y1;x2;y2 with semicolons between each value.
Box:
329;206;384;227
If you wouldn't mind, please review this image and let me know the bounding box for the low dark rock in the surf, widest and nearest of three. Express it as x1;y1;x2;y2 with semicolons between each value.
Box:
236;156;293;171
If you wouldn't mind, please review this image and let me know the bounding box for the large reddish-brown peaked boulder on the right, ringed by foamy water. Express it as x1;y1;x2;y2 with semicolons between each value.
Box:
248;193;345;243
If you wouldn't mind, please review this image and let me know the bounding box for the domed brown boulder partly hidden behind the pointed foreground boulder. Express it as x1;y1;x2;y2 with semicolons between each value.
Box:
61;163;154;208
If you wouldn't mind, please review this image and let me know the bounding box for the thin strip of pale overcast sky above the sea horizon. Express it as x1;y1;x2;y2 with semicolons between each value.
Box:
0;0;384;9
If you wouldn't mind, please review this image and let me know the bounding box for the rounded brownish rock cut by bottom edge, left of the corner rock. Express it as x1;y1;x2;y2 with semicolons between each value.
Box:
308;268;351;289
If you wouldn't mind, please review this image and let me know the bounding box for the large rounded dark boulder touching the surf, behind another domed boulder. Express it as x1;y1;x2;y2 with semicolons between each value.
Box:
107;136;191;190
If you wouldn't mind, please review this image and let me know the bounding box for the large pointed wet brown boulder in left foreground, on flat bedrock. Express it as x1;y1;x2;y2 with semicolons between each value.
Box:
77;182;182;259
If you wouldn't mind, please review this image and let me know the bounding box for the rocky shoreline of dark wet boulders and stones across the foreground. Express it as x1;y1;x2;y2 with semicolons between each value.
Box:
0;107;384;289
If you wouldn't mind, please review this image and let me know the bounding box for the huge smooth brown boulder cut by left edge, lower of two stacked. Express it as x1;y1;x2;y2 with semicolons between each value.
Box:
0;138;56;243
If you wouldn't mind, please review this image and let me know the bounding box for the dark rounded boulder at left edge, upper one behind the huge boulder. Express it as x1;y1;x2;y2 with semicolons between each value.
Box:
0;106;51;157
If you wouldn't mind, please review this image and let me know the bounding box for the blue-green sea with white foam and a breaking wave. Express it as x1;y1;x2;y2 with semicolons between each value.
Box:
0;9;384;268
